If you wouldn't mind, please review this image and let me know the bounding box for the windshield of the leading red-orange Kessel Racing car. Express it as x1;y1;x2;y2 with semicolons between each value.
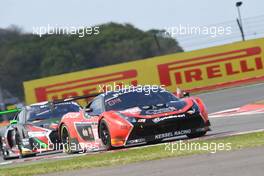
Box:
105;91;179;111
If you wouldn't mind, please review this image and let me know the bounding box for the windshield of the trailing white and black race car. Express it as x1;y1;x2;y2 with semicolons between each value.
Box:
27;103;80;122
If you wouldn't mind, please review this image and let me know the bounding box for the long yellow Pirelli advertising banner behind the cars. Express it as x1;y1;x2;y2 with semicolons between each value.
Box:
24;39;264;104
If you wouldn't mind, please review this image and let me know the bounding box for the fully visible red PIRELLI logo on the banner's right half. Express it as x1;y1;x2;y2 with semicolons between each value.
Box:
158;47;264;86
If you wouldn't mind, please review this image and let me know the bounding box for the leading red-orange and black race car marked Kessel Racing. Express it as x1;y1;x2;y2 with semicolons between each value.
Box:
59;87;210;153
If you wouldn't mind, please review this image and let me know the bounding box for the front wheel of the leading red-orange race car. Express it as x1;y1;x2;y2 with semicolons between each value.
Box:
99;120;113;150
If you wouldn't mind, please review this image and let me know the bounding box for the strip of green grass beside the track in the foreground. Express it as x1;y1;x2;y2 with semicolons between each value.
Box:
0;132;264;176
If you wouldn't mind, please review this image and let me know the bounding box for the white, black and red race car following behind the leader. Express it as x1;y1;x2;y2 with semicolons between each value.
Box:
0;102;82;159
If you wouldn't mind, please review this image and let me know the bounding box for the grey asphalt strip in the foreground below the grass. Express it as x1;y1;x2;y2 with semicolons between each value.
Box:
46;148;264;176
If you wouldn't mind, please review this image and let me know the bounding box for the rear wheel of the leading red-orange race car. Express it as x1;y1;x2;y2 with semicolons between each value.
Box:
60;125;76;154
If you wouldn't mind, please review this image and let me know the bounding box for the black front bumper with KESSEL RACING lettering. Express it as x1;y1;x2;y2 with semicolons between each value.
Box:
125;113;210;146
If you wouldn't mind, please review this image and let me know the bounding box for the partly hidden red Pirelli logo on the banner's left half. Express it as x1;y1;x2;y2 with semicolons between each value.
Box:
24;70;137;102
